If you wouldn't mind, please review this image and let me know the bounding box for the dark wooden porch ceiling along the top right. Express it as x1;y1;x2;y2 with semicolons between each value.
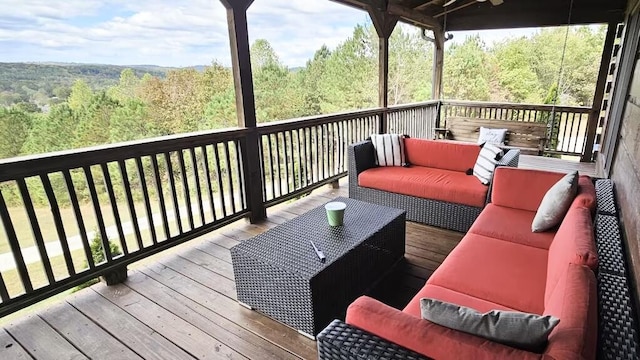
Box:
332;0;627;31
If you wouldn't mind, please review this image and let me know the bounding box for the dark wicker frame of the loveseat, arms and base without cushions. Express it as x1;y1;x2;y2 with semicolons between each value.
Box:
348;141;520;232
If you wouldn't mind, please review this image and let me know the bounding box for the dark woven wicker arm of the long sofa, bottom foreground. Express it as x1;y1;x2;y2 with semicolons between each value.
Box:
318;320;426;360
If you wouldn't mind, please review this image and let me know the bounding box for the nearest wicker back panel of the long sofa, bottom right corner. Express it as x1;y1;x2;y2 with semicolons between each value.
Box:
598;273;640;360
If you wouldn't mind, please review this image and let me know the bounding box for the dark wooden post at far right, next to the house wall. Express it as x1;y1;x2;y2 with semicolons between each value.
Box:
580;23;618;162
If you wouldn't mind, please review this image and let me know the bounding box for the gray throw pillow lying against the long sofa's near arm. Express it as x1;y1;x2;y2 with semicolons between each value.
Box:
420;298;560;352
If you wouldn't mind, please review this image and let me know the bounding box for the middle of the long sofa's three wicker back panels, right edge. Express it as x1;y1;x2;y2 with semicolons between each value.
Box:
595;214;625;276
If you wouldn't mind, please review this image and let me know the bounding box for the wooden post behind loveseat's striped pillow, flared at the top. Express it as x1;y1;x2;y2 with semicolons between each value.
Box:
367;0;398;134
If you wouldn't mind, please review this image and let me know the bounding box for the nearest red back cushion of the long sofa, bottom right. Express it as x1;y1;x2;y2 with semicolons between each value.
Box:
544;263;598;359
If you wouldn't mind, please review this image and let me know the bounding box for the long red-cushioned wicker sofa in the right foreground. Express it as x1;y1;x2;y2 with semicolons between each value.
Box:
318;167;598;360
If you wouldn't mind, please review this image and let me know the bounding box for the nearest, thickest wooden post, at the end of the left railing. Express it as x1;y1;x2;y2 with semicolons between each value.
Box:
220;0;267;223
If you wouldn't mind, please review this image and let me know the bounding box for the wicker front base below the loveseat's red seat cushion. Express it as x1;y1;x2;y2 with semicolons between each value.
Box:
349;185;483;232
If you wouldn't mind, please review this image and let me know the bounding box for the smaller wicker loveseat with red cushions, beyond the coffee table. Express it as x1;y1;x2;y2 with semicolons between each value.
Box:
348;139;520;232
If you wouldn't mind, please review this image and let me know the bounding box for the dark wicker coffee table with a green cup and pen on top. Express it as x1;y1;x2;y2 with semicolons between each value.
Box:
231;198;405;338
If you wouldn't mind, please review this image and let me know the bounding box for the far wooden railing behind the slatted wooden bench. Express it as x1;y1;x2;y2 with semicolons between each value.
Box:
438;101;591;156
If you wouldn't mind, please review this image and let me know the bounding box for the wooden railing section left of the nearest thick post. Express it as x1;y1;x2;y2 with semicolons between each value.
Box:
0;129;249;316
